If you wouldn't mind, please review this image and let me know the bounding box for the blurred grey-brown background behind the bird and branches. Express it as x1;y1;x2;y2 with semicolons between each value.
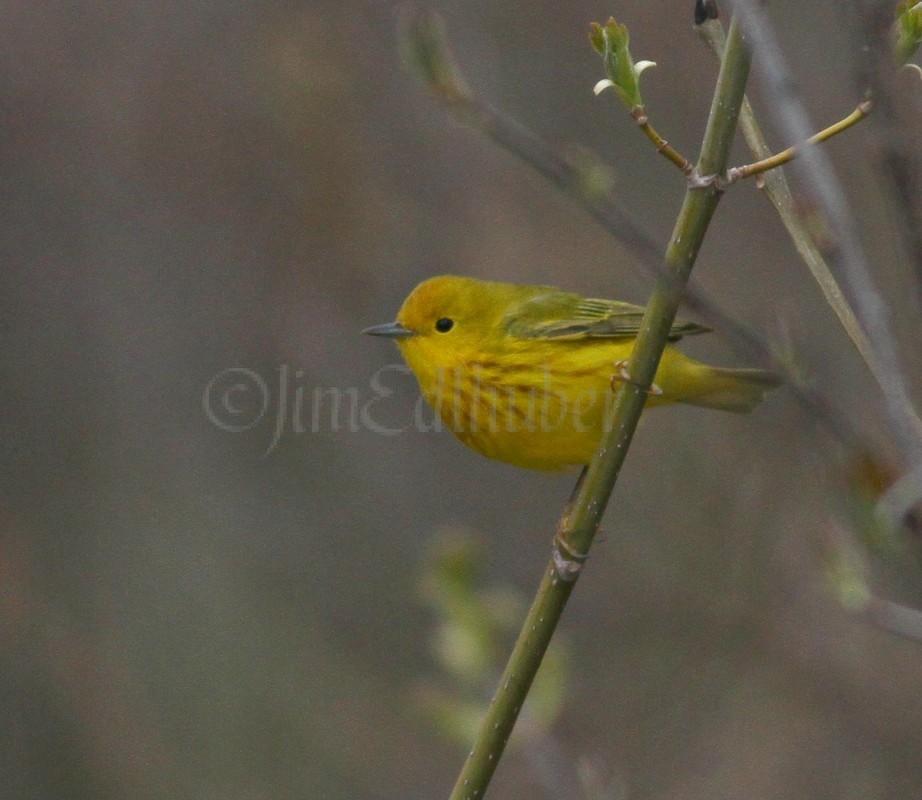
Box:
0;0;922;800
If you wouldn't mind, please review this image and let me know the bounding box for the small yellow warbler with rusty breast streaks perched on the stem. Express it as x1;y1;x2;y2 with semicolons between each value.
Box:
363;275;778;470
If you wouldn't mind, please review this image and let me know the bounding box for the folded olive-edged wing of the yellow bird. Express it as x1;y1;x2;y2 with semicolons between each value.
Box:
504;291;710;341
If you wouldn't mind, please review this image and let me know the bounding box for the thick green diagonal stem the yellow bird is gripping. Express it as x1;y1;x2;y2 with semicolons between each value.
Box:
450;12;749;800
